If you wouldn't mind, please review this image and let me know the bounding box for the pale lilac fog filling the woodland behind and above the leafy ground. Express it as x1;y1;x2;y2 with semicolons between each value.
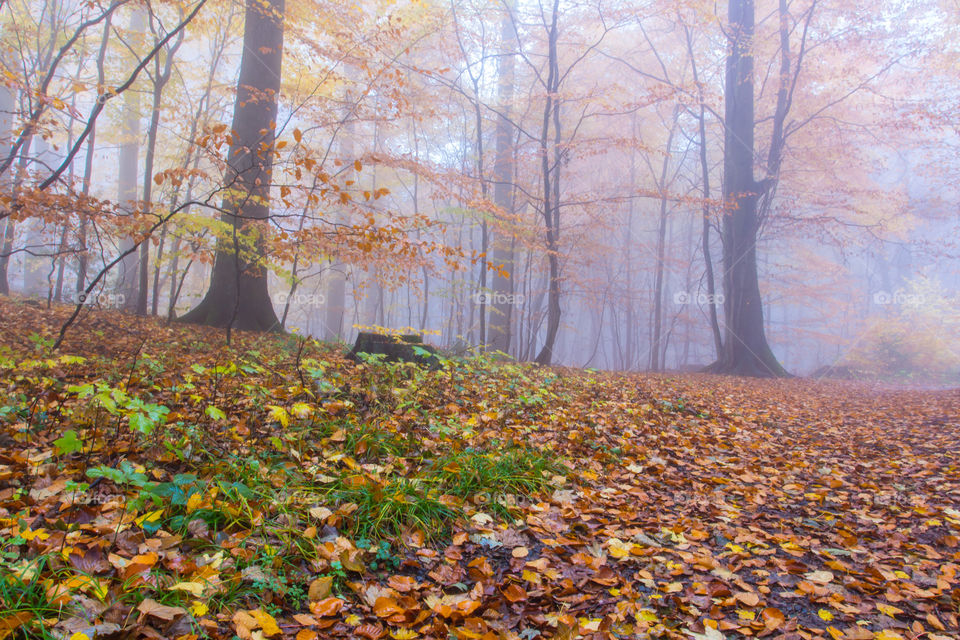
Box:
0;0;960;385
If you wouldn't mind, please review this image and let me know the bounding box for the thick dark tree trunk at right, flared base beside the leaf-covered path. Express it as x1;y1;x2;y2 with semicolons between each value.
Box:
709;0;788;377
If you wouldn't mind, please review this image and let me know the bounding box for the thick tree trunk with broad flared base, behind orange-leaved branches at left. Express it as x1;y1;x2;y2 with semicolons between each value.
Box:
180;0;284;331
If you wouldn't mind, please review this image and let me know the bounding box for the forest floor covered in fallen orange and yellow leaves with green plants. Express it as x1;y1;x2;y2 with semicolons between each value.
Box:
0;298;960;640
